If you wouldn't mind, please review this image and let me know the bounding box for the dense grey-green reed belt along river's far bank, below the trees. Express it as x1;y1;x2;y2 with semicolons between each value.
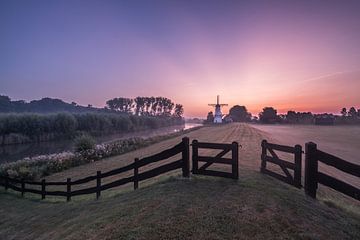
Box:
0;112;183;145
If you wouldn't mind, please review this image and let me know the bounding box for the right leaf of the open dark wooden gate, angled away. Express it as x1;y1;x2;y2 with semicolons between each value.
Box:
260;140;302;188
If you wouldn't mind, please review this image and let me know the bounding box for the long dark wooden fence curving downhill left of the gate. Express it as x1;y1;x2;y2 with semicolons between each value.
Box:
0;137;190;201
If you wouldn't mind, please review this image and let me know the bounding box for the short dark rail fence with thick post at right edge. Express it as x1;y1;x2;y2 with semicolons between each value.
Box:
305;142;360;200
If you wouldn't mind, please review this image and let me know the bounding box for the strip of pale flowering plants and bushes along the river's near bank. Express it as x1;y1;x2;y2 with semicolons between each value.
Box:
0;126;201;180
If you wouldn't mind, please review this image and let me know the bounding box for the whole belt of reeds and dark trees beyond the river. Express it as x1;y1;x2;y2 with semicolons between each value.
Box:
0;96;184;145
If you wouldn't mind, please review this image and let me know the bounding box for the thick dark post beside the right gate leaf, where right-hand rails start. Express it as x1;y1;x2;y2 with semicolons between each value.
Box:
305;142;318;198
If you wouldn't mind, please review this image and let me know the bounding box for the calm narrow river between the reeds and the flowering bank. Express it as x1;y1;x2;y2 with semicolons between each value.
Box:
0;123;202;164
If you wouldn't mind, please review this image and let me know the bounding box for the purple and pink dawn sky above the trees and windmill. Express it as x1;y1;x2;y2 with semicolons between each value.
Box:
0;0;360;117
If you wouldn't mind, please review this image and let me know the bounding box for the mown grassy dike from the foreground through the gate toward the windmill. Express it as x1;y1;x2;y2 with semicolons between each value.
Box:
0;124;360;239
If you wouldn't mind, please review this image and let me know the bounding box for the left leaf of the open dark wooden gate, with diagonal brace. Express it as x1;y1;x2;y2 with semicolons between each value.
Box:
192;140;239;179
